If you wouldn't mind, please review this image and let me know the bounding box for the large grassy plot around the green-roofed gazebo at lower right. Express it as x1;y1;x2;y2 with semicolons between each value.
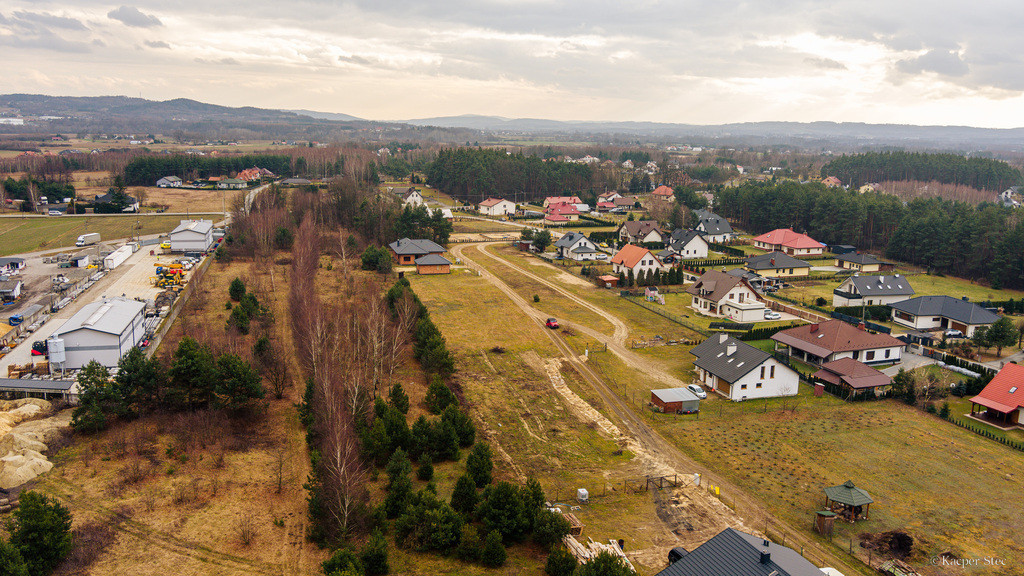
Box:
656;386;1024;574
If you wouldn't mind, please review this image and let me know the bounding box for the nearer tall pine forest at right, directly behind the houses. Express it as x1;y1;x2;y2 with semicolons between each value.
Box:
715;181;1024;288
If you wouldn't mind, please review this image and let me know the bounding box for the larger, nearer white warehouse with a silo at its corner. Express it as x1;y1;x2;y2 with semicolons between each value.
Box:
47;297;145;370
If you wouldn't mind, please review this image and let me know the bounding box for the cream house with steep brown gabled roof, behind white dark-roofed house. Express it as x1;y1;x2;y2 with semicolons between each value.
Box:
686;270;765;322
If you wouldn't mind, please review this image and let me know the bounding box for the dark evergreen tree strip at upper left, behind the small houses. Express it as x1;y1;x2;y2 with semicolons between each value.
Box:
125;154;296;186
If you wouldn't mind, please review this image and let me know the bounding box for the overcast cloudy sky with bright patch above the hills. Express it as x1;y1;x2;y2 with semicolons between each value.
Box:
0;0;1024;127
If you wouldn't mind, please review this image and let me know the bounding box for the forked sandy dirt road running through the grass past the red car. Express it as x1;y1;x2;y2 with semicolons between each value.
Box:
452;244;869;576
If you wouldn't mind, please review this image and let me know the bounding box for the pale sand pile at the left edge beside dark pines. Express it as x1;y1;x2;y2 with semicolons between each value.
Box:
0;399;72;489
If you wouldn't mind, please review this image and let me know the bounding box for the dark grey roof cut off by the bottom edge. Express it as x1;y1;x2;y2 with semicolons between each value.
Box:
656;528;824;576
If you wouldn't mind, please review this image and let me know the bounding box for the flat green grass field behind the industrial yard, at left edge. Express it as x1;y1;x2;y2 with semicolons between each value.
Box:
0;214;209;256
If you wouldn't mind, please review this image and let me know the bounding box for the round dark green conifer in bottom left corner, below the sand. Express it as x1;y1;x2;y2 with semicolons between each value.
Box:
8;491;72;576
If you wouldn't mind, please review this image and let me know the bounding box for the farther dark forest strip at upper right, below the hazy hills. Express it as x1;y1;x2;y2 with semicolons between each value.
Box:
821;152;1022;192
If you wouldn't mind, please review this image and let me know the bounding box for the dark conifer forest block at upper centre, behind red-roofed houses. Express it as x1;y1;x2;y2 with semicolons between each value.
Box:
427;149;594;203
